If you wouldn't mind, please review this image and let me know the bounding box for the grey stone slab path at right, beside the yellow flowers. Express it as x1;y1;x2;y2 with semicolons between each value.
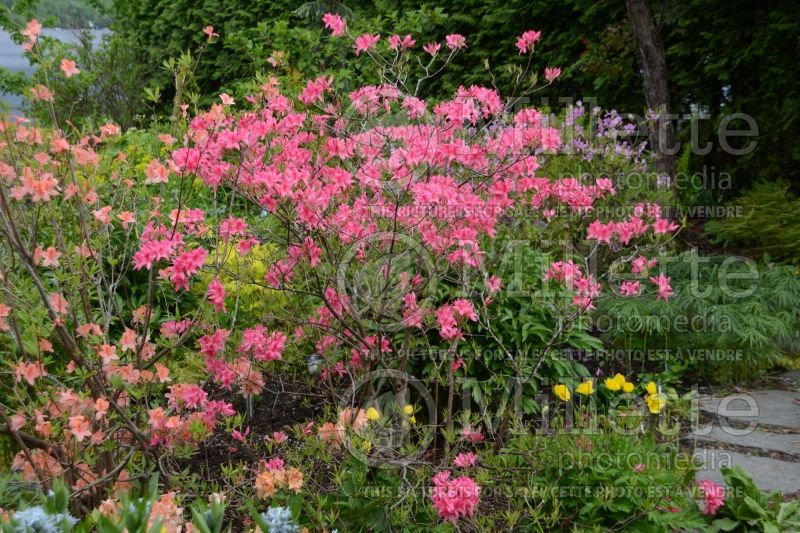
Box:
683;371;800;495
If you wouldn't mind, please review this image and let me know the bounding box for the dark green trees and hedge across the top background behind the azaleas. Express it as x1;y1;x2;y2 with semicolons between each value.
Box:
0;0;800;195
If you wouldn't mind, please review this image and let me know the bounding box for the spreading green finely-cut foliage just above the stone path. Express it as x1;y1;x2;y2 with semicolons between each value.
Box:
596;252;800;382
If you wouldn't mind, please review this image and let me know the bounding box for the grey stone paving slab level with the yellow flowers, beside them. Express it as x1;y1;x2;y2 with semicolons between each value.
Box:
700;390;800;431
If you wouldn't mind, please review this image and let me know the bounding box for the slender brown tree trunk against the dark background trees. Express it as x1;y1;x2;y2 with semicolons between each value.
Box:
625;0;677;182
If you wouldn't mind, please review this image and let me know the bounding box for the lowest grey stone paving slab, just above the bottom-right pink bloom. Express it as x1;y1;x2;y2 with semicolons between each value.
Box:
694;448;800;495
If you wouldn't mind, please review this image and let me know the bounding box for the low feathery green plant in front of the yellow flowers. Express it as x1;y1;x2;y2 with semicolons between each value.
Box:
486;420;703;532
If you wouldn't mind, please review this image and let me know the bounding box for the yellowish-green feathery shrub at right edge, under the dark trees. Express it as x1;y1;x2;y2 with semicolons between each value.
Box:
705;181;800;265
